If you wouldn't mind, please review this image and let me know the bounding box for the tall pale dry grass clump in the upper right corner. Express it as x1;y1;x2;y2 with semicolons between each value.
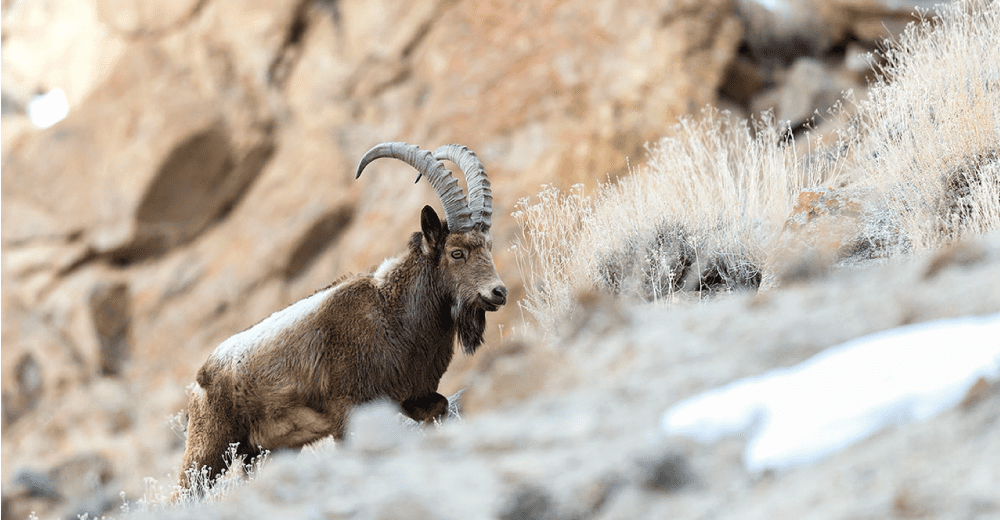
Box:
848;0;1000;251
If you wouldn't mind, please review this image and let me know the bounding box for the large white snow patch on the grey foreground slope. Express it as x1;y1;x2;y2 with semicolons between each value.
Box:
663;314;1000;472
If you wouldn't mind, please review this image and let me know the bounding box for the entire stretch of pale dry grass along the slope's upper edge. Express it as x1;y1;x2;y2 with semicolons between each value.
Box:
514;0;1000;333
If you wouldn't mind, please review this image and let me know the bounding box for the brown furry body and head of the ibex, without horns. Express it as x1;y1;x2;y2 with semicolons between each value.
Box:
180;206;506;492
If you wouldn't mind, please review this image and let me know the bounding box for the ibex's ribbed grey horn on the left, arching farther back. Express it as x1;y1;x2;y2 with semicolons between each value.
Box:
354;142;473;233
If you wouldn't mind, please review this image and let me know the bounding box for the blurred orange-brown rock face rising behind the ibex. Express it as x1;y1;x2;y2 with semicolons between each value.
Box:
0;0;933;519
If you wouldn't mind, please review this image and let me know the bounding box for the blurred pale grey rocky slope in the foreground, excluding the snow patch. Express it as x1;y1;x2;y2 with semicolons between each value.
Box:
141;233;1000;520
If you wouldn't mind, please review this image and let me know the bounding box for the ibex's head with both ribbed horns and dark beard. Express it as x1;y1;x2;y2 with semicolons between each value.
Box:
355;143;507;354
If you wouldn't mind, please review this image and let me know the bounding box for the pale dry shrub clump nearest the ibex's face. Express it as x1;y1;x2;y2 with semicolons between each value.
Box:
514;109;839;332
